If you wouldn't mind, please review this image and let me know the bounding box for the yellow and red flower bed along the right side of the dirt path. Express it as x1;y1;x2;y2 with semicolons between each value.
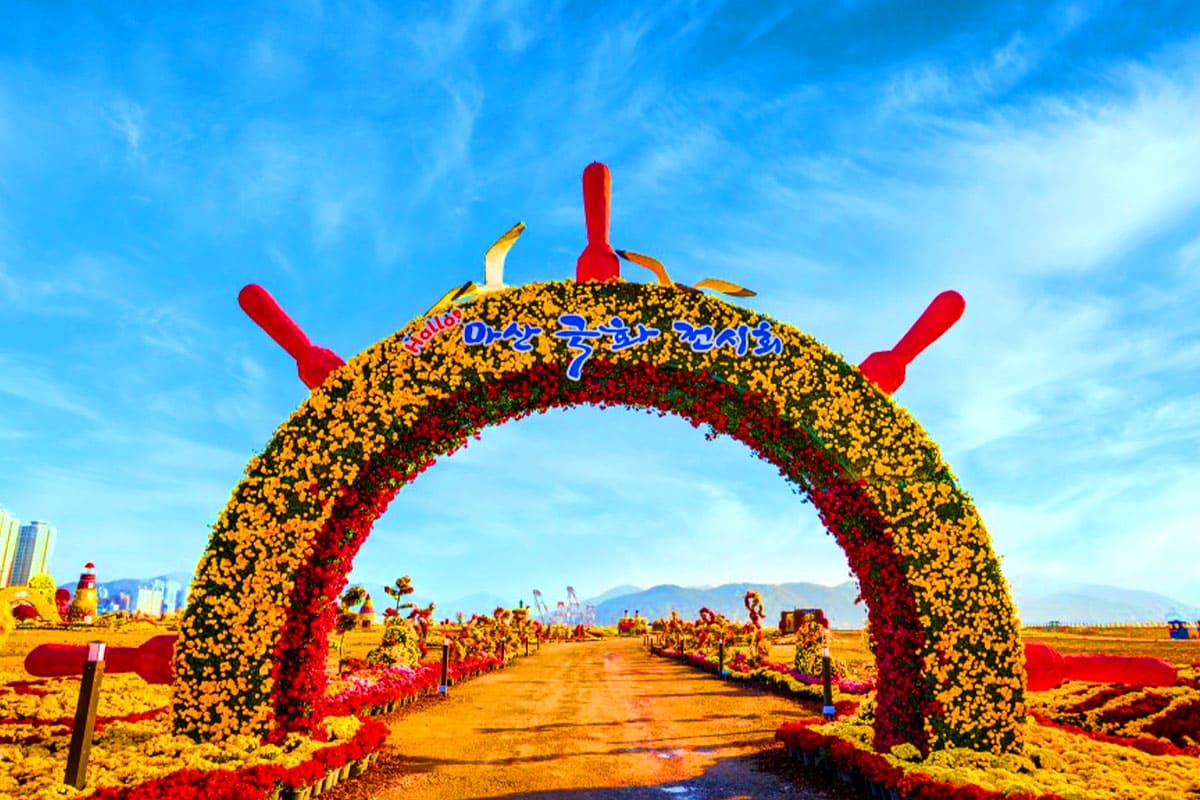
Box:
652;648;1200;800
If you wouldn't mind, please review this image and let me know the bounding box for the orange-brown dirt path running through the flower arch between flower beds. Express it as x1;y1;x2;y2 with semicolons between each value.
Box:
326;639;856;800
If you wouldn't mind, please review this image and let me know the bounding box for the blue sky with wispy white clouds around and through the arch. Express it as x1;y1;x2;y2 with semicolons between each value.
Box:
0;1;1200;604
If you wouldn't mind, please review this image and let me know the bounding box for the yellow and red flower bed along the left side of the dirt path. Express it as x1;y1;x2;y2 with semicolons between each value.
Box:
0;657;503;800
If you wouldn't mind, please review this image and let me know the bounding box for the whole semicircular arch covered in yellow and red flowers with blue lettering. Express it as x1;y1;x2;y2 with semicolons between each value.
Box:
173;281;1024;751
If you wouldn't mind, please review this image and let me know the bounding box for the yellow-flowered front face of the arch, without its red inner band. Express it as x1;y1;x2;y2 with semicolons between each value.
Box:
174;282;1024;751
